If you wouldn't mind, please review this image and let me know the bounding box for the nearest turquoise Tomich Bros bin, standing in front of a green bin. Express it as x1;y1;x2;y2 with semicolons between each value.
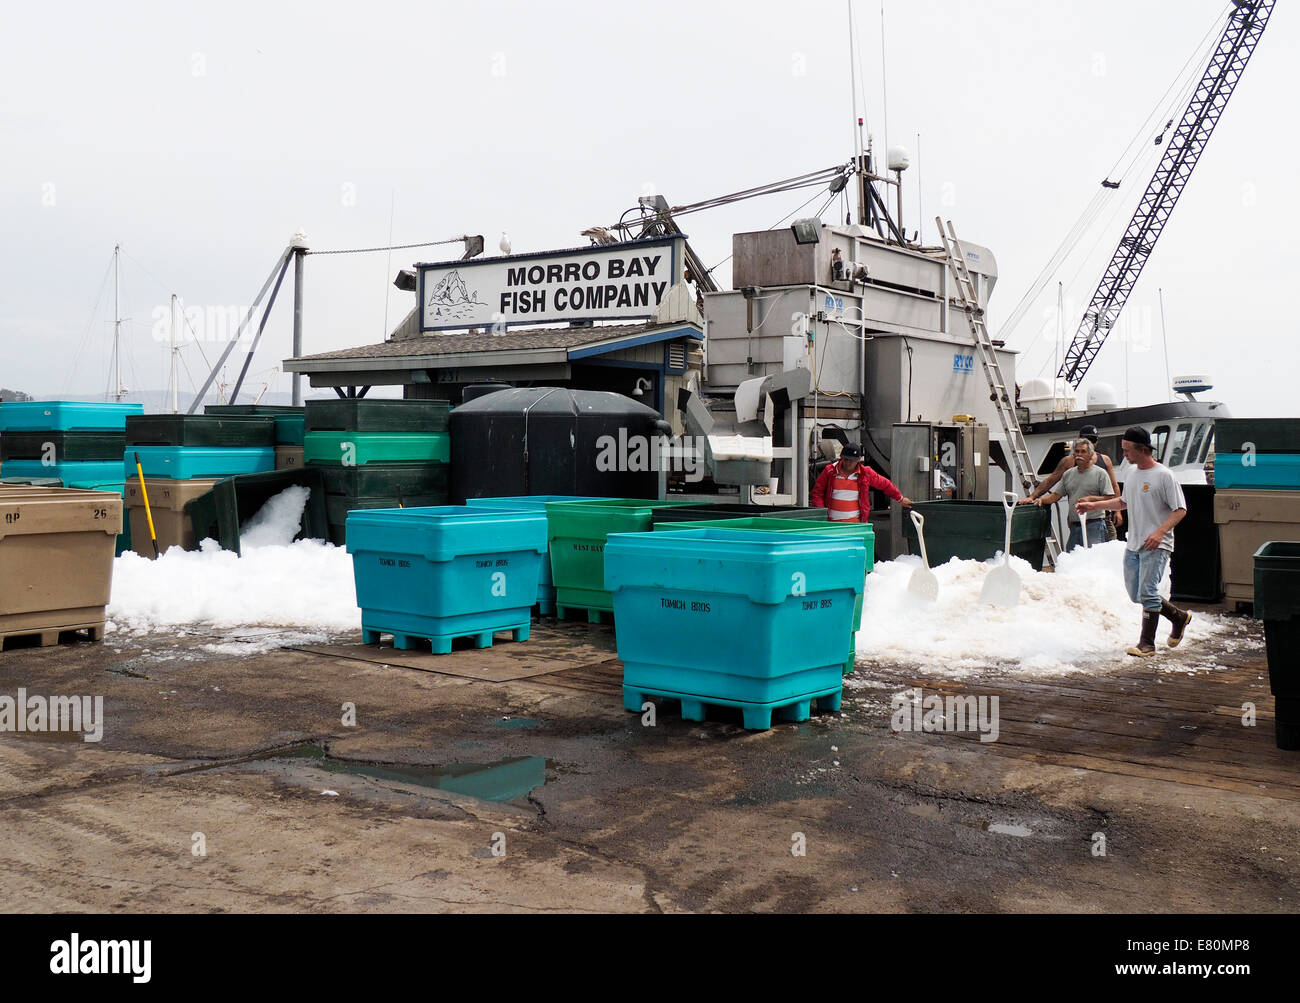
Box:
603;520;866;729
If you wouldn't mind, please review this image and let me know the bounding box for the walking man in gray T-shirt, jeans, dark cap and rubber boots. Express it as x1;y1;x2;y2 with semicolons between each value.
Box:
1075;427;1192;657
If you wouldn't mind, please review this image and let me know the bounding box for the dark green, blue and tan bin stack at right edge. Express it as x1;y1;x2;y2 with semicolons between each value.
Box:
1214;418;1300;603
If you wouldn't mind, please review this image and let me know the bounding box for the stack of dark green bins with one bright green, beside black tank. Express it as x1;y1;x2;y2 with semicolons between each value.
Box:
303;400;451;546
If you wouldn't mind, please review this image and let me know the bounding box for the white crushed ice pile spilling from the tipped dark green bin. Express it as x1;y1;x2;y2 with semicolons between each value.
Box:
108;487;361;654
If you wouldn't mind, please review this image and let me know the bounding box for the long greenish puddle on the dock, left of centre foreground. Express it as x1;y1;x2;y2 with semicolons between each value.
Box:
257;743;555;802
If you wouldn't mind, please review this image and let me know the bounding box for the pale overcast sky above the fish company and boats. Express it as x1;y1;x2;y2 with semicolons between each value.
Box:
0;0;1300;416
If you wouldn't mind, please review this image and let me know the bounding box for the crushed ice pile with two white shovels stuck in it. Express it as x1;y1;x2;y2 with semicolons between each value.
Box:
857;543;1231;677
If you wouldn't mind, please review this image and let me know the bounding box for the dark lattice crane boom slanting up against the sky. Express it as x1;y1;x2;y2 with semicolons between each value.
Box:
1057;0;1277;390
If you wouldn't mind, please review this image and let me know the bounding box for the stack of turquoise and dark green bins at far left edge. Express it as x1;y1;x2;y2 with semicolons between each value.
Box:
0;400;144;553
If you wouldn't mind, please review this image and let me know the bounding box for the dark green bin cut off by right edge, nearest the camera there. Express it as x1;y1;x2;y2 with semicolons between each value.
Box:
1255;540;1300;751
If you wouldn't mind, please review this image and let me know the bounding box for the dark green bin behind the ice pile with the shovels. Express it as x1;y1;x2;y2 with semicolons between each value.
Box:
902;502;1052;572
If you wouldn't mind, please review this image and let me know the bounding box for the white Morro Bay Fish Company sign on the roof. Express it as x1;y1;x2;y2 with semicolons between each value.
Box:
419;238;683;331
